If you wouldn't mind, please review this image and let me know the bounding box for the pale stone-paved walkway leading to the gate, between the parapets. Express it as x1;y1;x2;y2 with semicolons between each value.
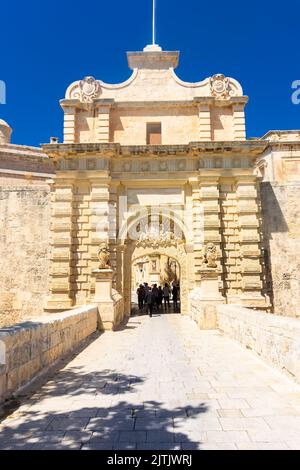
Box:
0;314;300;450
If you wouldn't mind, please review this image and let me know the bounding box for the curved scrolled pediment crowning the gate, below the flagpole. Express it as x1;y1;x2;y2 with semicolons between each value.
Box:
65;48;243;103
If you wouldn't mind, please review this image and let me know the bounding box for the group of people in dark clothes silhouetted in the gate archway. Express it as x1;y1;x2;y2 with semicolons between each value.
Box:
137;282;179;317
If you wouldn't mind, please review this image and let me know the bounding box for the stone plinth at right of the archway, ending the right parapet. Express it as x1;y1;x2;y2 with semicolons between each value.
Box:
189;267;225;330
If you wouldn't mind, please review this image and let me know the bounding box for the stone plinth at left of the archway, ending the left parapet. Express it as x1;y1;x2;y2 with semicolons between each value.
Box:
92;269;123;330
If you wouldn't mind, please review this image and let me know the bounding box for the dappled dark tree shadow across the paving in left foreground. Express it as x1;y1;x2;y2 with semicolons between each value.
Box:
0;367;208;450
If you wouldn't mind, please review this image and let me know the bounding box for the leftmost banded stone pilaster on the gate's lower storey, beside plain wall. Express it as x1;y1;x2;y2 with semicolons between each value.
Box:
46;179;74;311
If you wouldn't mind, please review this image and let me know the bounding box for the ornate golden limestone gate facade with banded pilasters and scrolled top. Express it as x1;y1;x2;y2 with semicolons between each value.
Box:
43;47;270;314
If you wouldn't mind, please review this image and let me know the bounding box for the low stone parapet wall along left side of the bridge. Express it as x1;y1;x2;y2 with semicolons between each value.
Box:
0;305;98;402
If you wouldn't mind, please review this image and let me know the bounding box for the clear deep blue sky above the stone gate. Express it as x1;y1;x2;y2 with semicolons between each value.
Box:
0;0;300;145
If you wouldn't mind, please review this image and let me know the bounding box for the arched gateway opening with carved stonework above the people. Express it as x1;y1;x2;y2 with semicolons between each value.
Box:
120;214;193;315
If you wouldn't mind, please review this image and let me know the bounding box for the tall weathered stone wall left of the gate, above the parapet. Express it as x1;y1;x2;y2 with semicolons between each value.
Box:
0;174;50;326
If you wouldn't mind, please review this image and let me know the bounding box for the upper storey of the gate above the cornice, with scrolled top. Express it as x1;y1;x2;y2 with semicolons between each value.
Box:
60;45;247;145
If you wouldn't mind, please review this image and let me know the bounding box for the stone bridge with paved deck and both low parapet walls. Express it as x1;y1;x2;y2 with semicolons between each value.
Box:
0;305;300;450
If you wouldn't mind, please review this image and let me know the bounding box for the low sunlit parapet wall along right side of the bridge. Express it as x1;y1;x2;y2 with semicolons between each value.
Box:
217;305;300;383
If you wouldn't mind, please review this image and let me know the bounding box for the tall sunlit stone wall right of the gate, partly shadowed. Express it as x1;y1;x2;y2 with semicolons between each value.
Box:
260;182;300;317
